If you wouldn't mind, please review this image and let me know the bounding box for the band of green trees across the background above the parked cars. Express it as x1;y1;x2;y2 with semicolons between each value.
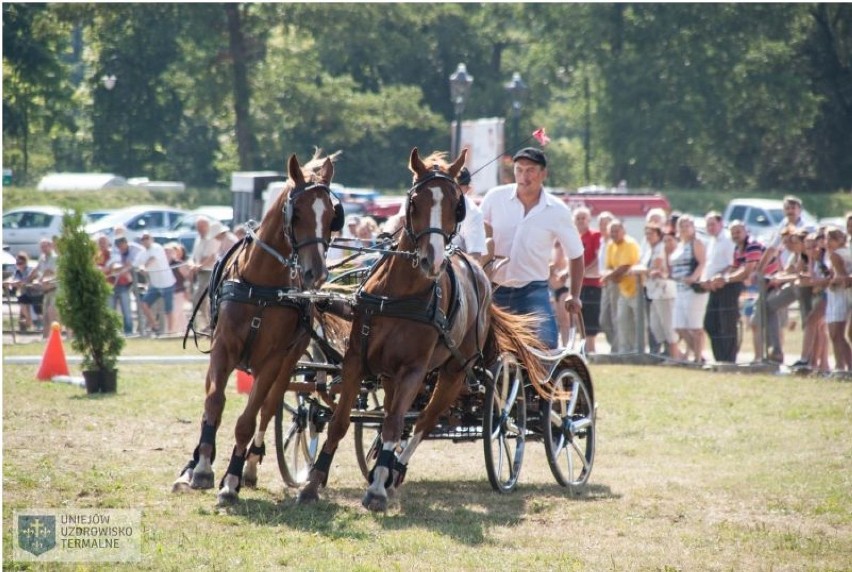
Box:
3;3;852;191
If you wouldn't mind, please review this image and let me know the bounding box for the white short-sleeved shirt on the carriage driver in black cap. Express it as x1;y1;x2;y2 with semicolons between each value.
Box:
480;183;583;288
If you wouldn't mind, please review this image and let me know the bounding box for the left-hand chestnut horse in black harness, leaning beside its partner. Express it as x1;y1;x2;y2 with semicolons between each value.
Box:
172;152;344;503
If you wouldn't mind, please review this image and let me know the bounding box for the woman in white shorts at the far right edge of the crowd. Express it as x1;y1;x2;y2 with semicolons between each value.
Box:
825;227;852;371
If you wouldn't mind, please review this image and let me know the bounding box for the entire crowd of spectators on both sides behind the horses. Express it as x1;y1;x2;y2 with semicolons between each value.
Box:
4;191;852;373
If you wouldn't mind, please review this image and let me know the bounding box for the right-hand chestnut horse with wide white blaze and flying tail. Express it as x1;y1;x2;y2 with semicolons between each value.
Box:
299;148;543;511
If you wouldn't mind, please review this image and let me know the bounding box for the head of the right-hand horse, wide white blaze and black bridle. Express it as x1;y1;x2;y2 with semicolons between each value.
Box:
405;147;467;279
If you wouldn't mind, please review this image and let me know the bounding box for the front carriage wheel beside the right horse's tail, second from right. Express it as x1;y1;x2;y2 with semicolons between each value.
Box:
482;354;527;493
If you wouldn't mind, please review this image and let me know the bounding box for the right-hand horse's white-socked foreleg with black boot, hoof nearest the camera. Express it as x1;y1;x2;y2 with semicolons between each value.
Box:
361;368;424;512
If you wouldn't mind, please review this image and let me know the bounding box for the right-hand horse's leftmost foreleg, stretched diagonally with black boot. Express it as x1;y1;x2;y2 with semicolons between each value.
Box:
299;360;362;504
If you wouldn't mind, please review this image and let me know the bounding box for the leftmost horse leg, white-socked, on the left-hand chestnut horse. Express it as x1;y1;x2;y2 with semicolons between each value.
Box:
172;358;233;493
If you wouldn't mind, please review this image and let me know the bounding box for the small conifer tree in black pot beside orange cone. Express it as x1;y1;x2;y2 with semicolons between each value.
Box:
56;211;124;393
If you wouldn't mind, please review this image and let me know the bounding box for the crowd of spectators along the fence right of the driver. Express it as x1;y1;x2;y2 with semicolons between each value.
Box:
576;196;852;373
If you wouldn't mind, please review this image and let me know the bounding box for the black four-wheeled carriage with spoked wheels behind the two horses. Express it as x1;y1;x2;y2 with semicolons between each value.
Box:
275;284;596;493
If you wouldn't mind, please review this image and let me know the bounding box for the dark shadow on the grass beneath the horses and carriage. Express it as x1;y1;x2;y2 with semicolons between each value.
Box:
227;480;618;546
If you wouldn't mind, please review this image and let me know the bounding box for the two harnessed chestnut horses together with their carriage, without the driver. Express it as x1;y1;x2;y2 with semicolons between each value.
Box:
172;148;595;511
